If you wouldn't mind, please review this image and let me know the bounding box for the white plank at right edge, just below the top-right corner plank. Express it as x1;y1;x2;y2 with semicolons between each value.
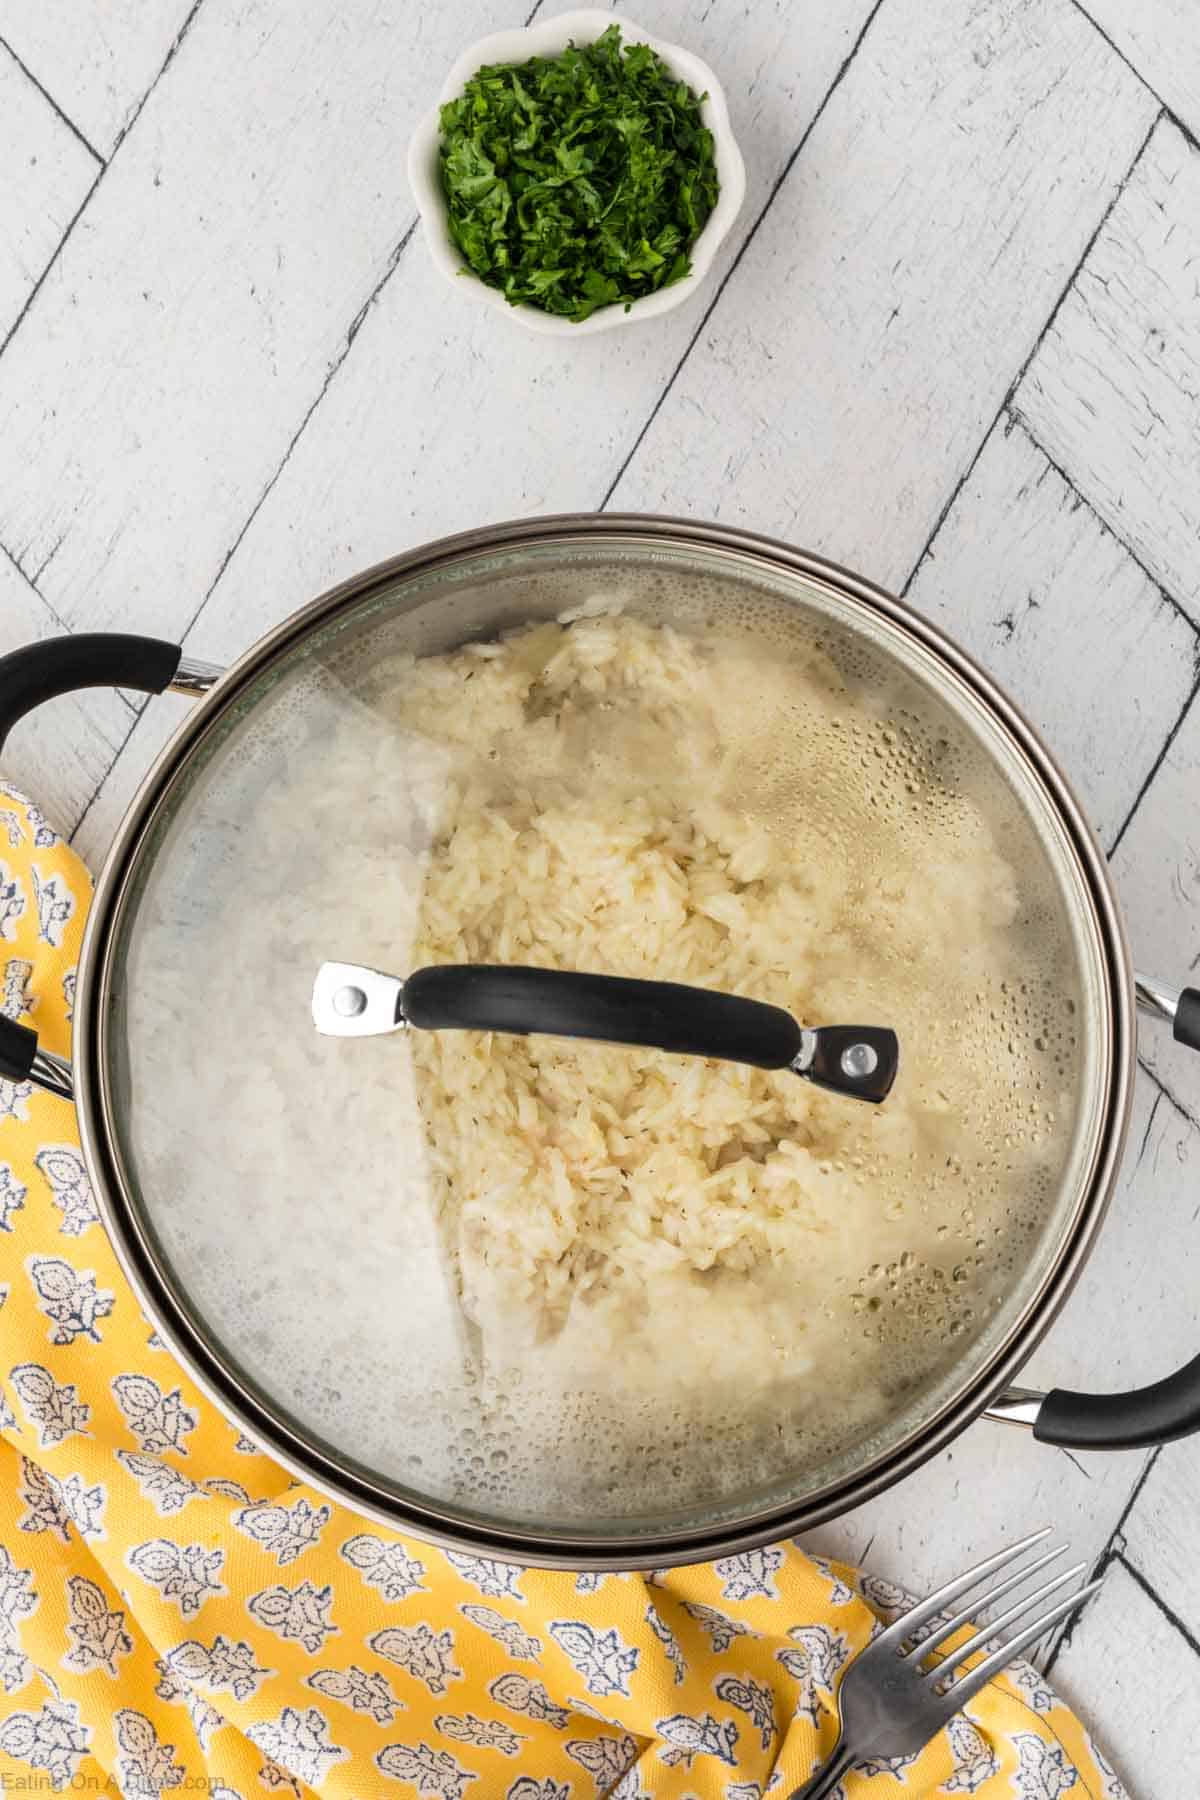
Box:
1016;121;1200;617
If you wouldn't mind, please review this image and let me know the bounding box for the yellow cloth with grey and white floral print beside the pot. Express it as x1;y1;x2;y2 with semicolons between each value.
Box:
0;790;1123;1800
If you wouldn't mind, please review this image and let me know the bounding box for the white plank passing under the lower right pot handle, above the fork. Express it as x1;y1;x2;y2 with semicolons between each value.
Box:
804;1075;1200;1620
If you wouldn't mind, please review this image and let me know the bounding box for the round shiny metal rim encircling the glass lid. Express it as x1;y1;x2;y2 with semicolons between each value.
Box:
74;513;1137;1571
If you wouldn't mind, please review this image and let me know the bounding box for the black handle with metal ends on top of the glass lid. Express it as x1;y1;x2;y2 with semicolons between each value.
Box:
313;963;900;1103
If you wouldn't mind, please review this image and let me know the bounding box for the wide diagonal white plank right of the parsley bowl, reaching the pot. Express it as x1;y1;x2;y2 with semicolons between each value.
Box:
613;0;1155;585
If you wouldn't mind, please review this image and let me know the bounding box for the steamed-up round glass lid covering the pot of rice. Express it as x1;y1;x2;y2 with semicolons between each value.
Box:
101;531;1108;1548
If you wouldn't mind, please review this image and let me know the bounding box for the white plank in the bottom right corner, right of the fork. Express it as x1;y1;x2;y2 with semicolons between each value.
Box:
1051;1562;1200;1800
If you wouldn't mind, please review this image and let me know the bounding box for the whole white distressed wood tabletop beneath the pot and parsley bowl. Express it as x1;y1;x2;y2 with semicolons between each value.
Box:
0;0;1200;1800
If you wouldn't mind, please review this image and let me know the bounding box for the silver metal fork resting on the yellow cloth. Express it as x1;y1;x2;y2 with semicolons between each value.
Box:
790;1525;1101;1800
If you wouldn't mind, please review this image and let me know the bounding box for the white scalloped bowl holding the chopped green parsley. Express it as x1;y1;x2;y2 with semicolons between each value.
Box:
408;7;747;337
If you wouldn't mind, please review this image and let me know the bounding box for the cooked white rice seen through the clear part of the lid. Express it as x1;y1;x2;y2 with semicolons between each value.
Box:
389;612;1072;1384
